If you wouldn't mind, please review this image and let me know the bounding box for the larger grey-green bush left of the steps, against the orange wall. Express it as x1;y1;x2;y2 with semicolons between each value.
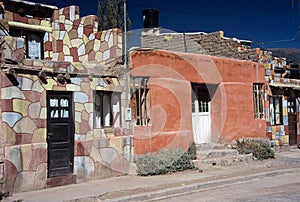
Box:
136;145;195;176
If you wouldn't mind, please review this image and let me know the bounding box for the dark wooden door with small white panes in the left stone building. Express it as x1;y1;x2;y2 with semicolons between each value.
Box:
47;91;74;178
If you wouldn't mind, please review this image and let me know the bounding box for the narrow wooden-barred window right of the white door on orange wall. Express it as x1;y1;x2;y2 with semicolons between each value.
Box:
253;84;264;119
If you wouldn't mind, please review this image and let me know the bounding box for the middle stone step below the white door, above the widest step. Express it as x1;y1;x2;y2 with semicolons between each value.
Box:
197;149;238;160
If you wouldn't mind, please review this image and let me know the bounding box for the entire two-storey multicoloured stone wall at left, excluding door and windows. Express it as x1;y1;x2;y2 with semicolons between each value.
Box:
0;1;129;193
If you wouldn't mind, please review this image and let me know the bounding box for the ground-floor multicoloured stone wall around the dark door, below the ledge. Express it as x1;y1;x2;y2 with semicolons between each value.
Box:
1;61;131;192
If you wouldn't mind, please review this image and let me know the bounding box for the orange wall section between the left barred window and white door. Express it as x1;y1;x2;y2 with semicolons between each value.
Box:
134;78;193;154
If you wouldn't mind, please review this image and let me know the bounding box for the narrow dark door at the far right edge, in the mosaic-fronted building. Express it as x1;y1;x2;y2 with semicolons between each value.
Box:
288;98;297;145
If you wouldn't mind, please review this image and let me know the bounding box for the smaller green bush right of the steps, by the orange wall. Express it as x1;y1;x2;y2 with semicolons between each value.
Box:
236;138;275;160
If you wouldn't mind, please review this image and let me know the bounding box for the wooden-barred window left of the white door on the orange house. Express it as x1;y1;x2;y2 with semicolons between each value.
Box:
131;77;150;126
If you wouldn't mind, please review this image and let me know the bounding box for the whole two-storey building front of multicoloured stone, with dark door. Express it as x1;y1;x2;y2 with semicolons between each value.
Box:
0;0;133;196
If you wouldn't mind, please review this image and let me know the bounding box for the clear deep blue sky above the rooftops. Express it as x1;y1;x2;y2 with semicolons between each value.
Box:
31;0;300;48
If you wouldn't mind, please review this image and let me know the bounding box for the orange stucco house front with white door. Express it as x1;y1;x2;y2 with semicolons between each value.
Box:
130;49;266;155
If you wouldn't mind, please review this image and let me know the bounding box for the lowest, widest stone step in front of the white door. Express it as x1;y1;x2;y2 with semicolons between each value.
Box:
193;154;253;169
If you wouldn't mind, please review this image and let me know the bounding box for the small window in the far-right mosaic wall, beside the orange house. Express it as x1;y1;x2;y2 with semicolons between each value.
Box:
270;96;282;125
